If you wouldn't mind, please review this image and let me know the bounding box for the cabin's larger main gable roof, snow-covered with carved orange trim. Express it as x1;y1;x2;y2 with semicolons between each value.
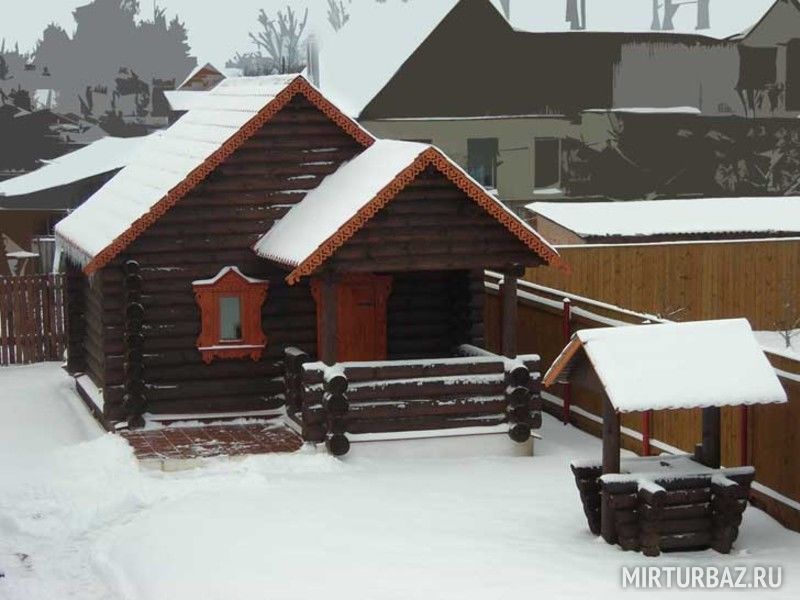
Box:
55;75;375;273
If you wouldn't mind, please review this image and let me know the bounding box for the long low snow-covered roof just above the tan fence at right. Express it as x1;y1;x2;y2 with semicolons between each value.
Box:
526;197;800;238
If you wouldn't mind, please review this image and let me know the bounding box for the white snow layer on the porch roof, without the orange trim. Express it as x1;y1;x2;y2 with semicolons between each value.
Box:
254;140;557;280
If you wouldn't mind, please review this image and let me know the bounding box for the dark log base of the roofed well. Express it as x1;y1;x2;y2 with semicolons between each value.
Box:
571;455;755;556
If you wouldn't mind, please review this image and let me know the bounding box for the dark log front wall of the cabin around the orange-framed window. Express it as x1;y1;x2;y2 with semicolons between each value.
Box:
88;97;361;416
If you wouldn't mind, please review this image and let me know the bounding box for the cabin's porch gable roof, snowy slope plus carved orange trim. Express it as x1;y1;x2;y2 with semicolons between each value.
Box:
254;140;560;284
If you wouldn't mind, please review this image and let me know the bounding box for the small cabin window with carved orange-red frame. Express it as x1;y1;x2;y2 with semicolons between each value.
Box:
192;267;269;363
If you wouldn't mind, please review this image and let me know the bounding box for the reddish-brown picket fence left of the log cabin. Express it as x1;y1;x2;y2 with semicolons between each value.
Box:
0;275;66;365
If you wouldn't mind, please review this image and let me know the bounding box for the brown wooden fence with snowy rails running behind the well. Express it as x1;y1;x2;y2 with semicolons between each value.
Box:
486;275;800;531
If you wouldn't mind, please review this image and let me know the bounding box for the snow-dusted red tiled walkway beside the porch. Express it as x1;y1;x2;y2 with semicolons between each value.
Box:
121;424;303;460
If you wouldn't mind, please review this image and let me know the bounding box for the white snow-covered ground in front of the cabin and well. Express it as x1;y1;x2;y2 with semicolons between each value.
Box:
0;364;800;600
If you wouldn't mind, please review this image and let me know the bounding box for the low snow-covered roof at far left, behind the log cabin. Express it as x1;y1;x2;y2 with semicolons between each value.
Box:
0;134;150;196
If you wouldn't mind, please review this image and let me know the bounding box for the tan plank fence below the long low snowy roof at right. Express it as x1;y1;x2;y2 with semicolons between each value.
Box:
525;239;800;330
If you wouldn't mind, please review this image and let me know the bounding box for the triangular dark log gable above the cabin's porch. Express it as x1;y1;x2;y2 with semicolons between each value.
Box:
328;167;538;272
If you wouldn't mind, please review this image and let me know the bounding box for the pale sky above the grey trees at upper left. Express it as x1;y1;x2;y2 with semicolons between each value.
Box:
0;0;330;65
